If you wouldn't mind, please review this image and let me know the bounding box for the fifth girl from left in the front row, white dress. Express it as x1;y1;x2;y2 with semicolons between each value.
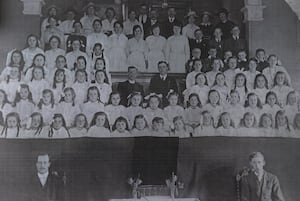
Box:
88;112;111;137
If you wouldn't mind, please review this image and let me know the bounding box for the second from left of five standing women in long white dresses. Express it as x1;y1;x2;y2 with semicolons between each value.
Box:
109;21;128;71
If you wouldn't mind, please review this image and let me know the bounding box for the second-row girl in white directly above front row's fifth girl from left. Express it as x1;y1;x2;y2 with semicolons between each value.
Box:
80;86;105;125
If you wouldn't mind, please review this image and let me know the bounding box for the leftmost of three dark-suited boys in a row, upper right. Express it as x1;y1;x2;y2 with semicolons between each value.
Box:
189;29;208;59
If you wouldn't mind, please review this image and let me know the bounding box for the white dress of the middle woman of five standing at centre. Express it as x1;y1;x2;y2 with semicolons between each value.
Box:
126;38;148;72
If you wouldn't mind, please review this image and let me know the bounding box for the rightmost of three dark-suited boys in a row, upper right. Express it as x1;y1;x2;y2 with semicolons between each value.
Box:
224;26;247;56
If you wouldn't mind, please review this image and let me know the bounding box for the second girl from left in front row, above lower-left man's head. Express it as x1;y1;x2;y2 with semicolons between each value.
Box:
20;112;48;138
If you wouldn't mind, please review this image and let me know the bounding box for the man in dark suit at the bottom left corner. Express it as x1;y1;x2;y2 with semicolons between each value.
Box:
27;154;64;201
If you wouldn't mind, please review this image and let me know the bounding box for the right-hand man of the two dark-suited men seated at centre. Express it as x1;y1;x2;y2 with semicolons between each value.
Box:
149;61;178;106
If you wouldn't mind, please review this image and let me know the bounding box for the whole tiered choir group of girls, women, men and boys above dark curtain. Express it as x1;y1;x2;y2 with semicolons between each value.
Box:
0;3;300;138
